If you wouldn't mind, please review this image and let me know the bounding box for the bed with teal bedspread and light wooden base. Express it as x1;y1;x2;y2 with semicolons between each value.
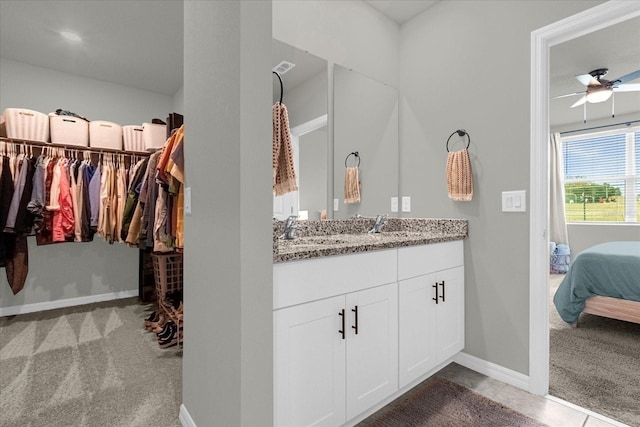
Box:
553;241;640;326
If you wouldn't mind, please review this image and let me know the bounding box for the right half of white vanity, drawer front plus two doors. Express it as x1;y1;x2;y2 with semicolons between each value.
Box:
398;241;464;388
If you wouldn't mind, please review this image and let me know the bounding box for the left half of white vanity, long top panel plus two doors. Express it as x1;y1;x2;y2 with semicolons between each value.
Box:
274;250;398;426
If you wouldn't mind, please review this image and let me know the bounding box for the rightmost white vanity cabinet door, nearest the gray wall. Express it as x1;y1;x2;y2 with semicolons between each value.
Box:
436;266;464;363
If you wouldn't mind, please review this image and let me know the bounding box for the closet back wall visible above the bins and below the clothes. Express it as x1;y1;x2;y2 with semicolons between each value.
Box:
0;58;172;312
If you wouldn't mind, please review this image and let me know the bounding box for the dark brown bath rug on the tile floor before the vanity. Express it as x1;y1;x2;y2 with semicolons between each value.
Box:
358;377;545;427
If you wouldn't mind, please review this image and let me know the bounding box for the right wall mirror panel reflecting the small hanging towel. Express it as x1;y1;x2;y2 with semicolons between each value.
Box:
333;65;398;219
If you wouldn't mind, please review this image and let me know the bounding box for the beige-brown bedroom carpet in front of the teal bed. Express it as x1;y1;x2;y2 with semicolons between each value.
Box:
549;275;640;427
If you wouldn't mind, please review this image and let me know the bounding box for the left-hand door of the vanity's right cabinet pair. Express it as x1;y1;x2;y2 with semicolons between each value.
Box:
398;274;437;388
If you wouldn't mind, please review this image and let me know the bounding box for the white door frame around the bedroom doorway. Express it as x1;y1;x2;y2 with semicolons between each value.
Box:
529;0;640;395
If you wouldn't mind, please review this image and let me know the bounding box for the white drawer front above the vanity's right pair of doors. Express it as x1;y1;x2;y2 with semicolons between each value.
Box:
398;240;464;280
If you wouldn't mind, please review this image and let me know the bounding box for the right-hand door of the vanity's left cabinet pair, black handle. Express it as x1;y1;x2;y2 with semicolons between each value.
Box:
346;283;398;419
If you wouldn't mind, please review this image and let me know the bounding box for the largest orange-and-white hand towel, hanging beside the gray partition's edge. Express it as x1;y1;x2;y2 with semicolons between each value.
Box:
272;103;298;196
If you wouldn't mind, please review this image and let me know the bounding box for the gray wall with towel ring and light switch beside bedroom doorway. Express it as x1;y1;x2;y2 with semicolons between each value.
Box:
400;1;601;374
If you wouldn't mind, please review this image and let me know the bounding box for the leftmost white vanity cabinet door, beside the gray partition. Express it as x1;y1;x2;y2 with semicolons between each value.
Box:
274;296;347;427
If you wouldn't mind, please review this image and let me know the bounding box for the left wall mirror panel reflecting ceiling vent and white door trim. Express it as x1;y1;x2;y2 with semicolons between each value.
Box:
272;39;330;219
